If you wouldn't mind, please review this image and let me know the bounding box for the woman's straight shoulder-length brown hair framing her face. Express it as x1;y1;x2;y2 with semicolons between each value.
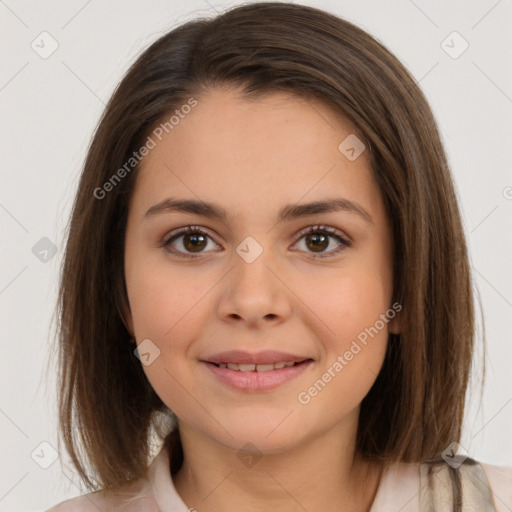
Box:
48;2;485;502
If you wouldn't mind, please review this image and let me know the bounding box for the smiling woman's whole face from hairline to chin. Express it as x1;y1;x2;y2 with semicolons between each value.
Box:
125;86;398;453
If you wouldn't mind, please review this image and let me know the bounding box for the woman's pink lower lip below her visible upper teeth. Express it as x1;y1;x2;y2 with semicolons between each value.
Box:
201;359;313;391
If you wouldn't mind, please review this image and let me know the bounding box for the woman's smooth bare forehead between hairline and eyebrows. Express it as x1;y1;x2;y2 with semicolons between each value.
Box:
130;89;379;222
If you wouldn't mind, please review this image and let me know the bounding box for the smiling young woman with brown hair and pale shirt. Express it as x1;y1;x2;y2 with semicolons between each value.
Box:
45;3;512;512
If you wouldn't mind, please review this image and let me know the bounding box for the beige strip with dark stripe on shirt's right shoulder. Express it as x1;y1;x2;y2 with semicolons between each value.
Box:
420;458;497;512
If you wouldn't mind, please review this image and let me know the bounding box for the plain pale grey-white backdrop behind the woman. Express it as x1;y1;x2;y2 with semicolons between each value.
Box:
0;0;512;512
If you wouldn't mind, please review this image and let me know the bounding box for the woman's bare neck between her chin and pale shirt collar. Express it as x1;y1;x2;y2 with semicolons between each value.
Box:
173;425;382;512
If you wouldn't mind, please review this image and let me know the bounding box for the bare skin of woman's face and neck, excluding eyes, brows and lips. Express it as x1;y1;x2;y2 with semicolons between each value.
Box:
125;88;400;512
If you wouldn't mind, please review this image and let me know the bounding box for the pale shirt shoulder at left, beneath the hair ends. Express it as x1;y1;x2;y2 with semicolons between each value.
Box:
45;479;160;512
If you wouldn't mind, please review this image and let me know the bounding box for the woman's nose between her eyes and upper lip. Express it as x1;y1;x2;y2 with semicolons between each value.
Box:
217;243;293;328
